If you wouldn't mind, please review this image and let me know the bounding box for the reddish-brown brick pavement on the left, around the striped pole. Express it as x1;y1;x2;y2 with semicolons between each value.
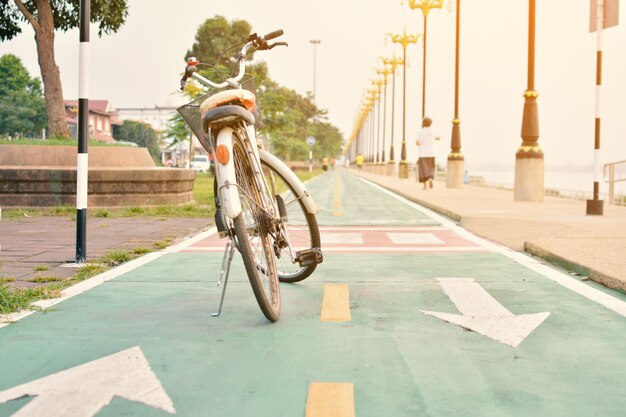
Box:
0;217;213;287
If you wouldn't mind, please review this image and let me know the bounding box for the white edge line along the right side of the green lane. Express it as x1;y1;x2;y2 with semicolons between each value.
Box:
359;177;626;317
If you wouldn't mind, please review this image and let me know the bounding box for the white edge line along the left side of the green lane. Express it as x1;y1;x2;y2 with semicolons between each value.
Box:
0;227;217;329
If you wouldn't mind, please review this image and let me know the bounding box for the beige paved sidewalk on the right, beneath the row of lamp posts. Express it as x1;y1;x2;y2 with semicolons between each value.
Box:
350;170;626;290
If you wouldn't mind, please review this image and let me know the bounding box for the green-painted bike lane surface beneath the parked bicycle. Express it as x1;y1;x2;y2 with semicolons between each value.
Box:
0;167;626;417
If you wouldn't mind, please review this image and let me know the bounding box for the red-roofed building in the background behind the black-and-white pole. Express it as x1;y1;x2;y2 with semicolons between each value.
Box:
65;100;122;142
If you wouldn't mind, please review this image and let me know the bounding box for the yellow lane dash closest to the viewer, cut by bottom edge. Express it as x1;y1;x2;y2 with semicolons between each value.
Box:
305;382;355;417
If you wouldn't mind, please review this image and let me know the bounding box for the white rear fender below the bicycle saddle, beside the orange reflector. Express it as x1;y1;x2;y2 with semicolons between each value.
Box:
216;127;241;219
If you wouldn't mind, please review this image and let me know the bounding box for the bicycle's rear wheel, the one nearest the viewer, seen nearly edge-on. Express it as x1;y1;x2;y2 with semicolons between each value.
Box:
233;131;281;322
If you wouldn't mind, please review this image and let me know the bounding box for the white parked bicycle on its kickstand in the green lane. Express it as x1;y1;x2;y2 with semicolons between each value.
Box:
178;30;323;322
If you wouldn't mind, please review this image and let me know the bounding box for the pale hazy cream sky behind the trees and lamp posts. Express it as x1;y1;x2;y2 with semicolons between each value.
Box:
0;0;626;173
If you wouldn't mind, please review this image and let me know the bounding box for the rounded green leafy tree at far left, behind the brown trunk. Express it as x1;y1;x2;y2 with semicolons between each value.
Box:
0;55;47;136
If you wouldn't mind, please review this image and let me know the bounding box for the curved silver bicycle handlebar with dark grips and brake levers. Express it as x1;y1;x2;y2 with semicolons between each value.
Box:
180;29;289;91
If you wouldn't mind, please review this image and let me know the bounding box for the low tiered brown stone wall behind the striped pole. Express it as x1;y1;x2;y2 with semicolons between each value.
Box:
0;145;196;208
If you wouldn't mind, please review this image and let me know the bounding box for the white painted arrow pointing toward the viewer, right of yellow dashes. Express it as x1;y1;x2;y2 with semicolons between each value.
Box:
422;278;550;347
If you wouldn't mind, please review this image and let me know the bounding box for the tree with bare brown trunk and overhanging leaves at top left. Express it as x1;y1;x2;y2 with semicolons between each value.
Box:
0;0;128;138
